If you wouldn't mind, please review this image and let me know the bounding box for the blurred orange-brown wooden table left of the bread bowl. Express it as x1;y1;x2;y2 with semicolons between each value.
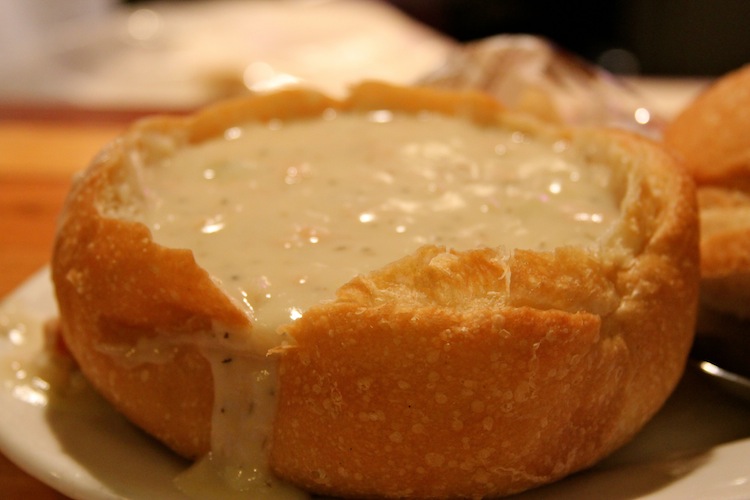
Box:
0;105;181;500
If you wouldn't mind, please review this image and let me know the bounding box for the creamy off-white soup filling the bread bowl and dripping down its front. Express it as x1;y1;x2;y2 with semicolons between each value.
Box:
122;106;618;498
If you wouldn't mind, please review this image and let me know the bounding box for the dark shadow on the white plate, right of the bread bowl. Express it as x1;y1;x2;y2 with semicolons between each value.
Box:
512;368;750;500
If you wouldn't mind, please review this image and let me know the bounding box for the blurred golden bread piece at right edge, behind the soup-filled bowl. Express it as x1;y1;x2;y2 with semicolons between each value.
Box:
664;65;750;319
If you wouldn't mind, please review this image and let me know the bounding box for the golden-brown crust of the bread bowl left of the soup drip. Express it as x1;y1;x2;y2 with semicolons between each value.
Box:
52;144;226;456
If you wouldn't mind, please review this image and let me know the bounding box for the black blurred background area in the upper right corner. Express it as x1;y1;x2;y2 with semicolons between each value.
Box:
392;0;750;76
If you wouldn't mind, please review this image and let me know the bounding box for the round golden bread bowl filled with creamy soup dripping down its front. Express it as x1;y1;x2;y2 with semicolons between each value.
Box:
52;83;699;498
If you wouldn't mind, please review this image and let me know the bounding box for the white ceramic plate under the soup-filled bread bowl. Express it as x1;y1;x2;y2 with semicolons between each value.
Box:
0;269;750;500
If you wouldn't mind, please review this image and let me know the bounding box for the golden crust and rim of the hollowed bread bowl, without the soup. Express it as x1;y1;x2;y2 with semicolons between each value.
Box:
52;83;698;497
